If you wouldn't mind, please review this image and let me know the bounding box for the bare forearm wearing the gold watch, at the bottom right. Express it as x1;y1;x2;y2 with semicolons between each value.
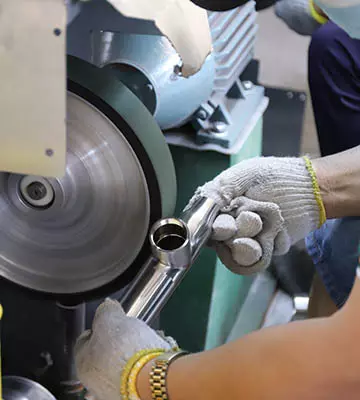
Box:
138;280;360;400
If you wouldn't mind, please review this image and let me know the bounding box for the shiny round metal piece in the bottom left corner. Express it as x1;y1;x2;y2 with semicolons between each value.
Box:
3;376;56;400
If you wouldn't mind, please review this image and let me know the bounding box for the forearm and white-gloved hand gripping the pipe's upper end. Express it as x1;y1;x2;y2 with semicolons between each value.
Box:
190;146;360;274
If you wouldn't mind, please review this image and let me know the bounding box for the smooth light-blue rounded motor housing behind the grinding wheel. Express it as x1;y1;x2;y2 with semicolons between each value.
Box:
92;33;215;129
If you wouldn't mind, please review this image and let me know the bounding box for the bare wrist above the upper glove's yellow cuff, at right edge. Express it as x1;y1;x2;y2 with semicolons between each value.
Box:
313;146;360;219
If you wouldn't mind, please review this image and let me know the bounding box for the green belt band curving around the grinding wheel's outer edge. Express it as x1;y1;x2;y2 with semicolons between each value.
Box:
67;56;176;216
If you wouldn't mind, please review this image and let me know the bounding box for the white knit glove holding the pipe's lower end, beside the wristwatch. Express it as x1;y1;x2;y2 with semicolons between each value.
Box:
75;299;177;400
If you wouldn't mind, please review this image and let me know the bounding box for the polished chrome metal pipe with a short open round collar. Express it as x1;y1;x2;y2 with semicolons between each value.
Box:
120;198;220;323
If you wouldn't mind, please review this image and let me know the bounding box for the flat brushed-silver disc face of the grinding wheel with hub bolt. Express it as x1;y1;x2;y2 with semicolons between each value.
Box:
0;93;150;293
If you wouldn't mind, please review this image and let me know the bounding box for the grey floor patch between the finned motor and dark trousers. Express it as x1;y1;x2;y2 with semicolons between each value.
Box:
255;7;319;157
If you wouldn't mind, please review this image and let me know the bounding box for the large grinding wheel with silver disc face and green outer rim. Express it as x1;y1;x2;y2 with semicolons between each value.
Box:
0;57;176;297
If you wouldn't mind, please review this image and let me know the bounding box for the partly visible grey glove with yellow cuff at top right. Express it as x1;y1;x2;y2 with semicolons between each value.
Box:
275;0;327;36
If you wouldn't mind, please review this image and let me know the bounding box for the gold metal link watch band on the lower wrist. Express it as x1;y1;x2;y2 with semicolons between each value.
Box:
150;351;189;400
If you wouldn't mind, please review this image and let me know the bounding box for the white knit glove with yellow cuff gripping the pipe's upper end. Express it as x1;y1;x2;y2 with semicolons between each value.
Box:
189;157;326;274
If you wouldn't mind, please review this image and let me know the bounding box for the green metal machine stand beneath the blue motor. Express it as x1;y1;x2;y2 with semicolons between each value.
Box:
160;119;262;352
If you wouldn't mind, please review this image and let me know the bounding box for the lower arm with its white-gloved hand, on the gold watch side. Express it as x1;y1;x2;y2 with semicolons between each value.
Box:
76;280;360;400
